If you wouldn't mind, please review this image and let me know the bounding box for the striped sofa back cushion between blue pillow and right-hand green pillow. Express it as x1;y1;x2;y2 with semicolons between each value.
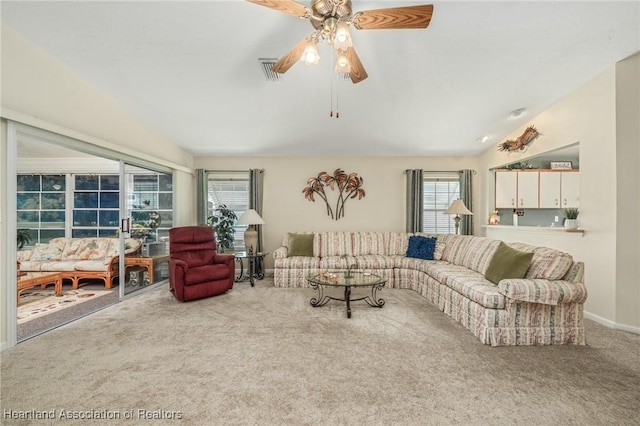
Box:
442;235;500;275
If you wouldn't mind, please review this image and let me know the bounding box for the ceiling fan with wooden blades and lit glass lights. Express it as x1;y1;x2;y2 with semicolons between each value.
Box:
247;0;433;84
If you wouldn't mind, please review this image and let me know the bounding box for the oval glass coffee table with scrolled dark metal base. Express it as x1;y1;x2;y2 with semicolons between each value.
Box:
307;272;387;318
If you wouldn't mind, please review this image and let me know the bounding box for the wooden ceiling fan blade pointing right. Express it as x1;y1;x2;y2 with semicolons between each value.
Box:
353;4;433;30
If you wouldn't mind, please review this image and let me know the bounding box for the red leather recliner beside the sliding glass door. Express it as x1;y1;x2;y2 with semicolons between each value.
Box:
169;226;236;302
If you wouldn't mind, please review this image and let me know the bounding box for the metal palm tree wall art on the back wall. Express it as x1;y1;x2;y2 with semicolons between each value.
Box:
302;169;365;220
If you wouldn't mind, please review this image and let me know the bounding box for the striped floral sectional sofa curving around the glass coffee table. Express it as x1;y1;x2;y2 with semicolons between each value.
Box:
273;232;587;346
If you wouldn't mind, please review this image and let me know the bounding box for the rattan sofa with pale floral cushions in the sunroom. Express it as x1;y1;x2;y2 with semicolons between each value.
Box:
17;237;142;288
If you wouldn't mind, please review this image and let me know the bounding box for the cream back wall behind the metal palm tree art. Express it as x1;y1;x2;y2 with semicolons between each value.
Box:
195;157;480;268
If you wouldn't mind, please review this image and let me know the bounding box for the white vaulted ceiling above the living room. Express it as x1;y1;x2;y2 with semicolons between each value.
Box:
1;0;640;156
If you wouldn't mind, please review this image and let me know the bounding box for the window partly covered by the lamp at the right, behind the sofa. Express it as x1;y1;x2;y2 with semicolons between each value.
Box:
422;172;460;234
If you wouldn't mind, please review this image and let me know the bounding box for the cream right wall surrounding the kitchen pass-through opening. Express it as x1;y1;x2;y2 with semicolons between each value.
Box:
480;55;640;332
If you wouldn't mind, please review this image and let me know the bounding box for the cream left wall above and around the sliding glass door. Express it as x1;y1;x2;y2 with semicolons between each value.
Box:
0;25;195;348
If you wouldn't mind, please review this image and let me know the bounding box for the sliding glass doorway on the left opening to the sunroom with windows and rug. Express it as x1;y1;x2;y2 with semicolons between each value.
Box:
7;124;173;342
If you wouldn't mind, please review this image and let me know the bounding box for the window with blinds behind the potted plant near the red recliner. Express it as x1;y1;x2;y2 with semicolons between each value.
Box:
207;172;249;251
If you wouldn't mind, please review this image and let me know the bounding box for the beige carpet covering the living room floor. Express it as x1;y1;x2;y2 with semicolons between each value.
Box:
0;279;640;425
